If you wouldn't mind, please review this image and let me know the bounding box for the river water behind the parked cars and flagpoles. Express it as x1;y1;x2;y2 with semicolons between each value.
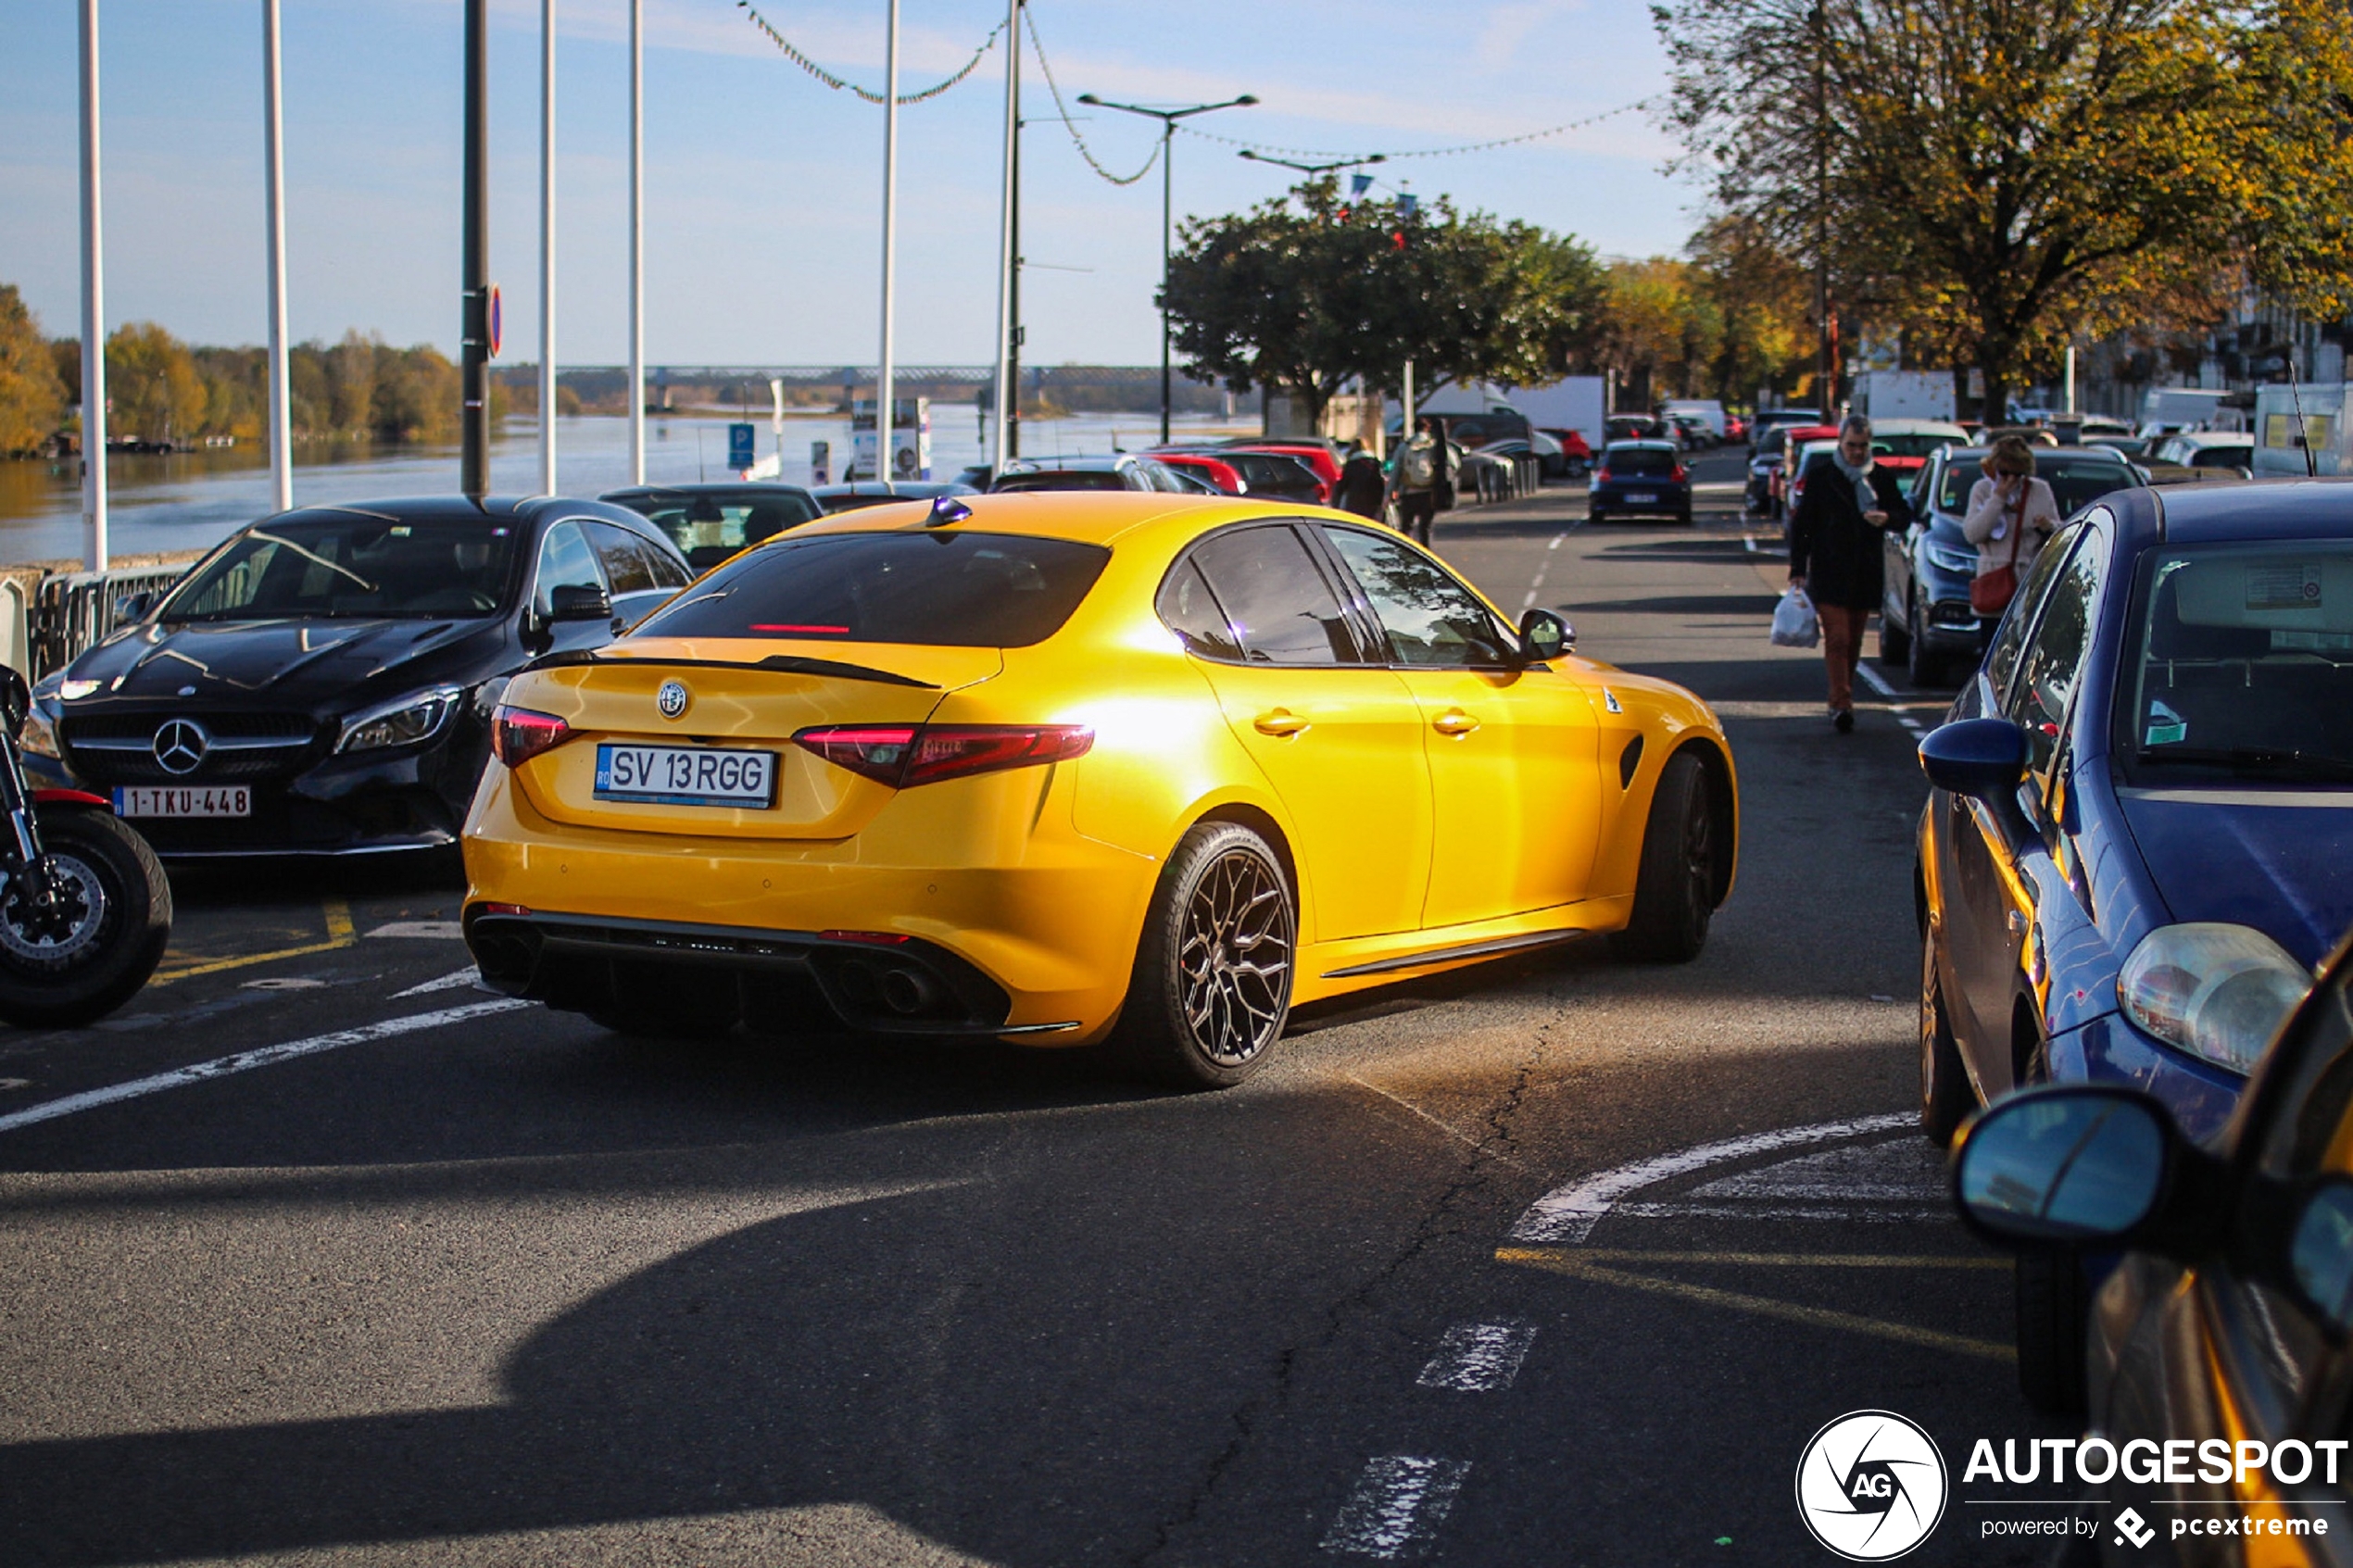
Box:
0;405;1254;564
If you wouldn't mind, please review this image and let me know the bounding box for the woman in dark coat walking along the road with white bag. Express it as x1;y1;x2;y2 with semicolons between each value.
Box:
1788;414;1910;734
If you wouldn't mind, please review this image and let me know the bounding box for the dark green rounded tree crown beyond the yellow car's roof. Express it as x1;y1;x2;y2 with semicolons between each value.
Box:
1164;176;1603;420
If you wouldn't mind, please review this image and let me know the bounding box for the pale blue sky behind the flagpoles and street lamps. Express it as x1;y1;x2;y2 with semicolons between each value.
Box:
0;0;1699;364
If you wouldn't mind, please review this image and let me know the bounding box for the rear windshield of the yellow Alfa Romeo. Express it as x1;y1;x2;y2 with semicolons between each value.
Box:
637;529;1111;649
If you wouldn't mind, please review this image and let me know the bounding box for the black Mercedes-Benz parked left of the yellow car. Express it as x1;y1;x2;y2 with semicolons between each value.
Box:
23;496;694;860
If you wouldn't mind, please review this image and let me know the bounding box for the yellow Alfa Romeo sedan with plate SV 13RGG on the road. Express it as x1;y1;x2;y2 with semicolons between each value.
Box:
466;494;1739;1086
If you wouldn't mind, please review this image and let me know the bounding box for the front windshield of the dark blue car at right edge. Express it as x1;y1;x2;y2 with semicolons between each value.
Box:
2118;538;2353;785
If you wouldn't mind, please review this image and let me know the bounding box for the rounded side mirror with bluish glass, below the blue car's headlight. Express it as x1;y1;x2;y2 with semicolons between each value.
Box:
1953;1084;2173;1246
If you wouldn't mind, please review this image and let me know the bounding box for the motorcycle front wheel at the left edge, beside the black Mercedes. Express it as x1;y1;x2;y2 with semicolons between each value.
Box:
0;807;171;1030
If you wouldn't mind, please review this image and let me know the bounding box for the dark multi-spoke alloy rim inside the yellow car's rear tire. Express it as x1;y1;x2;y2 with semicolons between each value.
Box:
1176;848;1291;1067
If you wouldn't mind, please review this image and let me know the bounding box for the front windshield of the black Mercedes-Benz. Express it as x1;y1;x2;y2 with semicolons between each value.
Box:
160;512;520;621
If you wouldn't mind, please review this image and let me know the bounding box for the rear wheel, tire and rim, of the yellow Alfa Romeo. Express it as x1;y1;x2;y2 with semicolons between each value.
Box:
1111;822;1299;1088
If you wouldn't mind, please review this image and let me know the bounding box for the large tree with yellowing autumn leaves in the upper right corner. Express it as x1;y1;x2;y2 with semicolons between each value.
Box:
1655;0;2353;409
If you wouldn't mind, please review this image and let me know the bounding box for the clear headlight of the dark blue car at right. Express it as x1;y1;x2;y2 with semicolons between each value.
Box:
2115;922;2313;1072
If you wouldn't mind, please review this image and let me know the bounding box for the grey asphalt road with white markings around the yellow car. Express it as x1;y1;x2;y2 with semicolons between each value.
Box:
0;454;2059;1568
